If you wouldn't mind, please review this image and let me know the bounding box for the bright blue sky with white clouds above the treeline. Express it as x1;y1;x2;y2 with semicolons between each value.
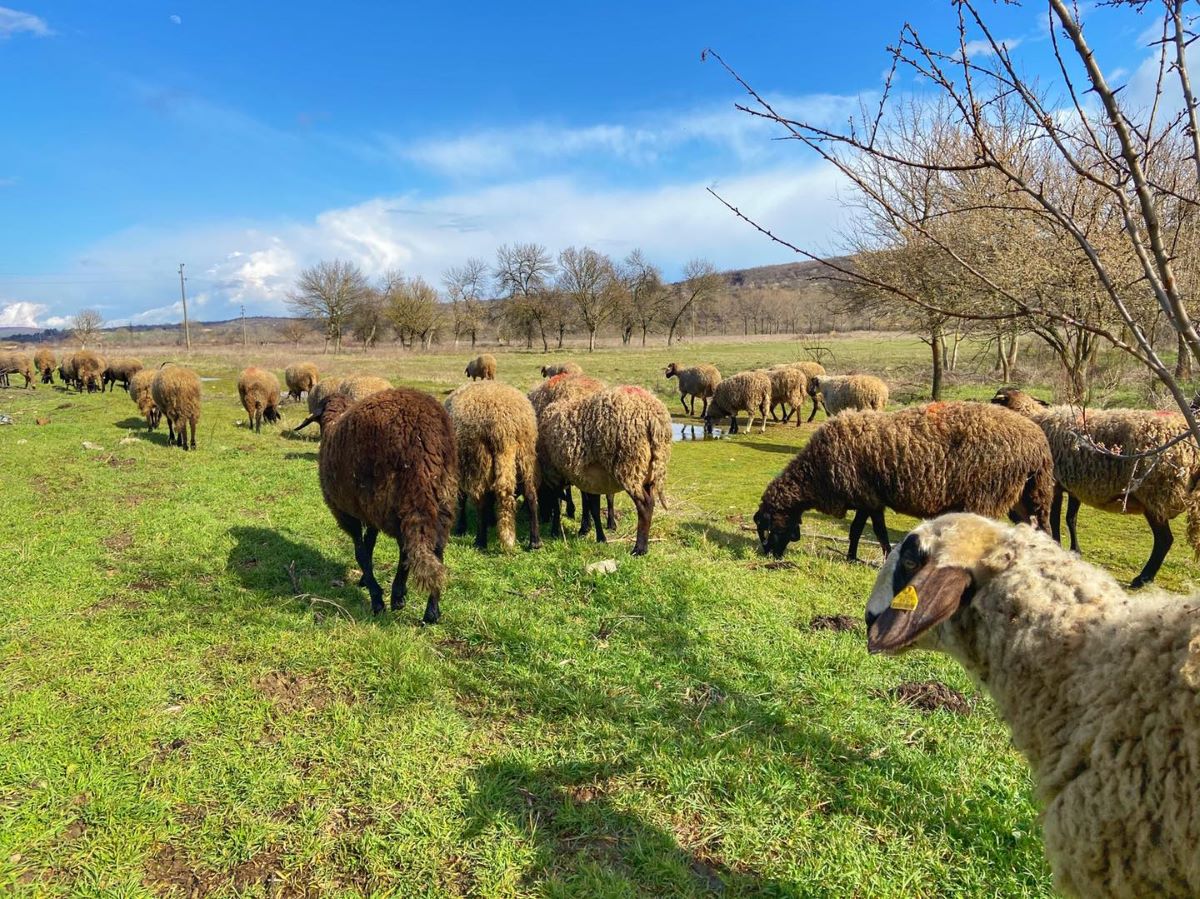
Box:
0;0;1166;325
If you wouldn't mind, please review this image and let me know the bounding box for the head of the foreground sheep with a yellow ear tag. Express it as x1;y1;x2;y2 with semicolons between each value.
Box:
866;513;1004;653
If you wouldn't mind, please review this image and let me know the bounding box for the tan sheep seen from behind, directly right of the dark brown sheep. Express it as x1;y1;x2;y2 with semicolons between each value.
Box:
445;380;541;550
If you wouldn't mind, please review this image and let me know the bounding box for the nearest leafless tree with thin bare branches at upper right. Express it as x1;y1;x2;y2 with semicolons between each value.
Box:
700;0;1200;442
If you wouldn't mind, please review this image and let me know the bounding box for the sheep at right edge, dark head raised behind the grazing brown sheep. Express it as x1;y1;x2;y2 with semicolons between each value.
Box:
992;388;1200;588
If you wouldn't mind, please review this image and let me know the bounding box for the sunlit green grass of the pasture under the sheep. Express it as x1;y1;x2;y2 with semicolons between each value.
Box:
0;338;1193;897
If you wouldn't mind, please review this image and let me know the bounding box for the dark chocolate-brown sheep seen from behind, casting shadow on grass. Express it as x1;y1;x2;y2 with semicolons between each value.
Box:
298;388;458;624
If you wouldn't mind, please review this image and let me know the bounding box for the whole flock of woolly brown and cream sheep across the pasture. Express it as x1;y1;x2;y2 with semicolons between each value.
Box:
7;350;1200;895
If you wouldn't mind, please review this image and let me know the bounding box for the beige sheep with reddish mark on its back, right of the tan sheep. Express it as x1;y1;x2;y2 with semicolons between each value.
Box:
538;385;671;556
